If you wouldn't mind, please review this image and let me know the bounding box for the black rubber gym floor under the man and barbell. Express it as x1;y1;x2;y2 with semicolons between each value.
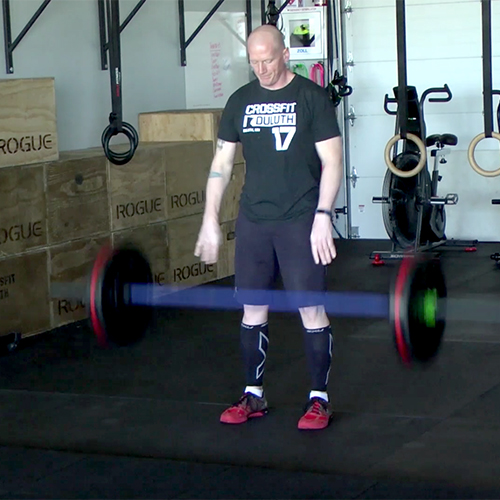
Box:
0;240;500;499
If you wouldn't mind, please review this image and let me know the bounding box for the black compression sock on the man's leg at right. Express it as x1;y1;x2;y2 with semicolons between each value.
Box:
304;325;333;392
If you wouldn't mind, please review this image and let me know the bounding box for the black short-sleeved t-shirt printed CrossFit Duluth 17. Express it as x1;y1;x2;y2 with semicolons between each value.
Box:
218;75;340;222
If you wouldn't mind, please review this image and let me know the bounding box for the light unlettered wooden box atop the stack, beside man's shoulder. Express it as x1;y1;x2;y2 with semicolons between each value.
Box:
139;109;245;163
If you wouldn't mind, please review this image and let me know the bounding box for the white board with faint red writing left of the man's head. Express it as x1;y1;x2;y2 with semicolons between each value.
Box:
185;12;250;109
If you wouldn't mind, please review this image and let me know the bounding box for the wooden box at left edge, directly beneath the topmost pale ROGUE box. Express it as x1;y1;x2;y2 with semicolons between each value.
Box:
0;165;47;257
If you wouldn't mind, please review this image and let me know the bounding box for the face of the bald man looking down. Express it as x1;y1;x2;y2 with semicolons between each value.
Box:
248;41;289;89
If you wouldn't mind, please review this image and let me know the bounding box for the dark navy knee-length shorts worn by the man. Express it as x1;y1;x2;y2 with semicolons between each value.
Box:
235;212;327;307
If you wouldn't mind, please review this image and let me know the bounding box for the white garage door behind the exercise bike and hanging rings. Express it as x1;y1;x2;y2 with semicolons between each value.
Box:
346;0;500;241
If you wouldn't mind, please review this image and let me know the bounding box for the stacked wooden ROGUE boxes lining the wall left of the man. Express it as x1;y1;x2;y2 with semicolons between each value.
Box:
0;79;244;336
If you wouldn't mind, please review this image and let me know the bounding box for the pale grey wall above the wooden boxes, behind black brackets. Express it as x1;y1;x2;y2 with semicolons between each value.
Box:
0;0;270;151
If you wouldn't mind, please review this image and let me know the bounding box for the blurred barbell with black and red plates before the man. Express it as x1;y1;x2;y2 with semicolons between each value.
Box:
47;245;500;365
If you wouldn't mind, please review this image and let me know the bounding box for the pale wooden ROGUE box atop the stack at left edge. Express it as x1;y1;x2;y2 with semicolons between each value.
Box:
0;78;59;167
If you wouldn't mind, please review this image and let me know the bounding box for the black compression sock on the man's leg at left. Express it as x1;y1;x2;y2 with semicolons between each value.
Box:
240;323;269;386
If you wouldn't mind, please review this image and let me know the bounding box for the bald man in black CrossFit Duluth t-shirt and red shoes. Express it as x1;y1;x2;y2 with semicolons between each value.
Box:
195;25;342;429
